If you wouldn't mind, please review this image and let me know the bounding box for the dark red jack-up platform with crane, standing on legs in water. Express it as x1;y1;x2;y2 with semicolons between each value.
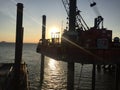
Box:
37;0;120;90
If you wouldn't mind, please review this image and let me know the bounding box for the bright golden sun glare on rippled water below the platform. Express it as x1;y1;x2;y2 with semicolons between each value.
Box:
42;57;67;90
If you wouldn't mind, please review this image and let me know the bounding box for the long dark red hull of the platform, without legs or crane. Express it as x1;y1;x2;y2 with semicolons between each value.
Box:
37;44;120;64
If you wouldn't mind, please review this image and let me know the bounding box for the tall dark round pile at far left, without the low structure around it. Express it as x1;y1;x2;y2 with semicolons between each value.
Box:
14;3;23;90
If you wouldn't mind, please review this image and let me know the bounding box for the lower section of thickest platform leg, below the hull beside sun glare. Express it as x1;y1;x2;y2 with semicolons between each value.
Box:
67;62;74;90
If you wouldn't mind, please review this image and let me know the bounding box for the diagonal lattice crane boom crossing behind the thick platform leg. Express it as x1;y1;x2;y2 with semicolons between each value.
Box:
62;0;89;30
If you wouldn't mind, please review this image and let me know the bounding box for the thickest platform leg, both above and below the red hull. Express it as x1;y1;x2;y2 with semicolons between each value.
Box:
67;0;76;90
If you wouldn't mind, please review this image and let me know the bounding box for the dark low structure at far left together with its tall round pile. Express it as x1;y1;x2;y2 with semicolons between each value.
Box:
0;3;29;90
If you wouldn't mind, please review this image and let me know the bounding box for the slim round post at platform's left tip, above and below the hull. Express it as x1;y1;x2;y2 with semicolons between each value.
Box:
40;15;46;87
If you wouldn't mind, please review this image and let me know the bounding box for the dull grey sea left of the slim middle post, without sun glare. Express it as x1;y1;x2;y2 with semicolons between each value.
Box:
0;43;40;90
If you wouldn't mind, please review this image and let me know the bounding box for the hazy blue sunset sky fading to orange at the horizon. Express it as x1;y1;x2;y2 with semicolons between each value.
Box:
0;0;120;43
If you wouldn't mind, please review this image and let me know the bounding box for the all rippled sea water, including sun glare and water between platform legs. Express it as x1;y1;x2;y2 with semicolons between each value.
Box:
0;43;115;90
